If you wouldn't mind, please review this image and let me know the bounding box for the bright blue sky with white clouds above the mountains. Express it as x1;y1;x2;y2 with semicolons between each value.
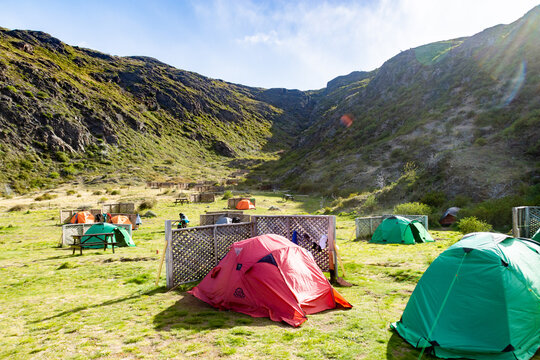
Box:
0;0;540;90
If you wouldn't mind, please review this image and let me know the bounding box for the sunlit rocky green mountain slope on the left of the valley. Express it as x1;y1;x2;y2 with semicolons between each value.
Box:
0;28;312;192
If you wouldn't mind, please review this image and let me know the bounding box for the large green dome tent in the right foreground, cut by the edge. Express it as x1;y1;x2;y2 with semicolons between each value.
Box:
391;233;540;360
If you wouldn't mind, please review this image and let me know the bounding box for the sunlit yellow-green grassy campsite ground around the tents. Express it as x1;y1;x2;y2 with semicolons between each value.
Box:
0;188;540;359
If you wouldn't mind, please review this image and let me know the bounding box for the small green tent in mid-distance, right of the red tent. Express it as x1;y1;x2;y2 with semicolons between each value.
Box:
370;216;433;244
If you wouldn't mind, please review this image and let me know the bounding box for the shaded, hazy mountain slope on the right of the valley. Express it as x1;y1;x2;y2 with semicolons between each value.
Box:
261;7;540;200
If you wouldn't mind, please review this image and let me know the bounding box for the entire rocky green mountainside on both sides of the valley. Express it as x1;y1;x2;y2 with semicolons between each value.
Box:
0;7;540;201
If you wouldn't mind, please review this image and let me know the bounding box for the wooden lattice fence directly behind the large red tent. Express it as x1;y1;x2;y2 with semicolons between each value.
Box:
165;215;337;288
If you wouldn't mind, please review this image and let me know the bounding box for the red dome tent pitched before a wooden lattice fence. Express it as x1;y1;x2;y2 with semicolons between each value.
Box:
189;234;352;327
